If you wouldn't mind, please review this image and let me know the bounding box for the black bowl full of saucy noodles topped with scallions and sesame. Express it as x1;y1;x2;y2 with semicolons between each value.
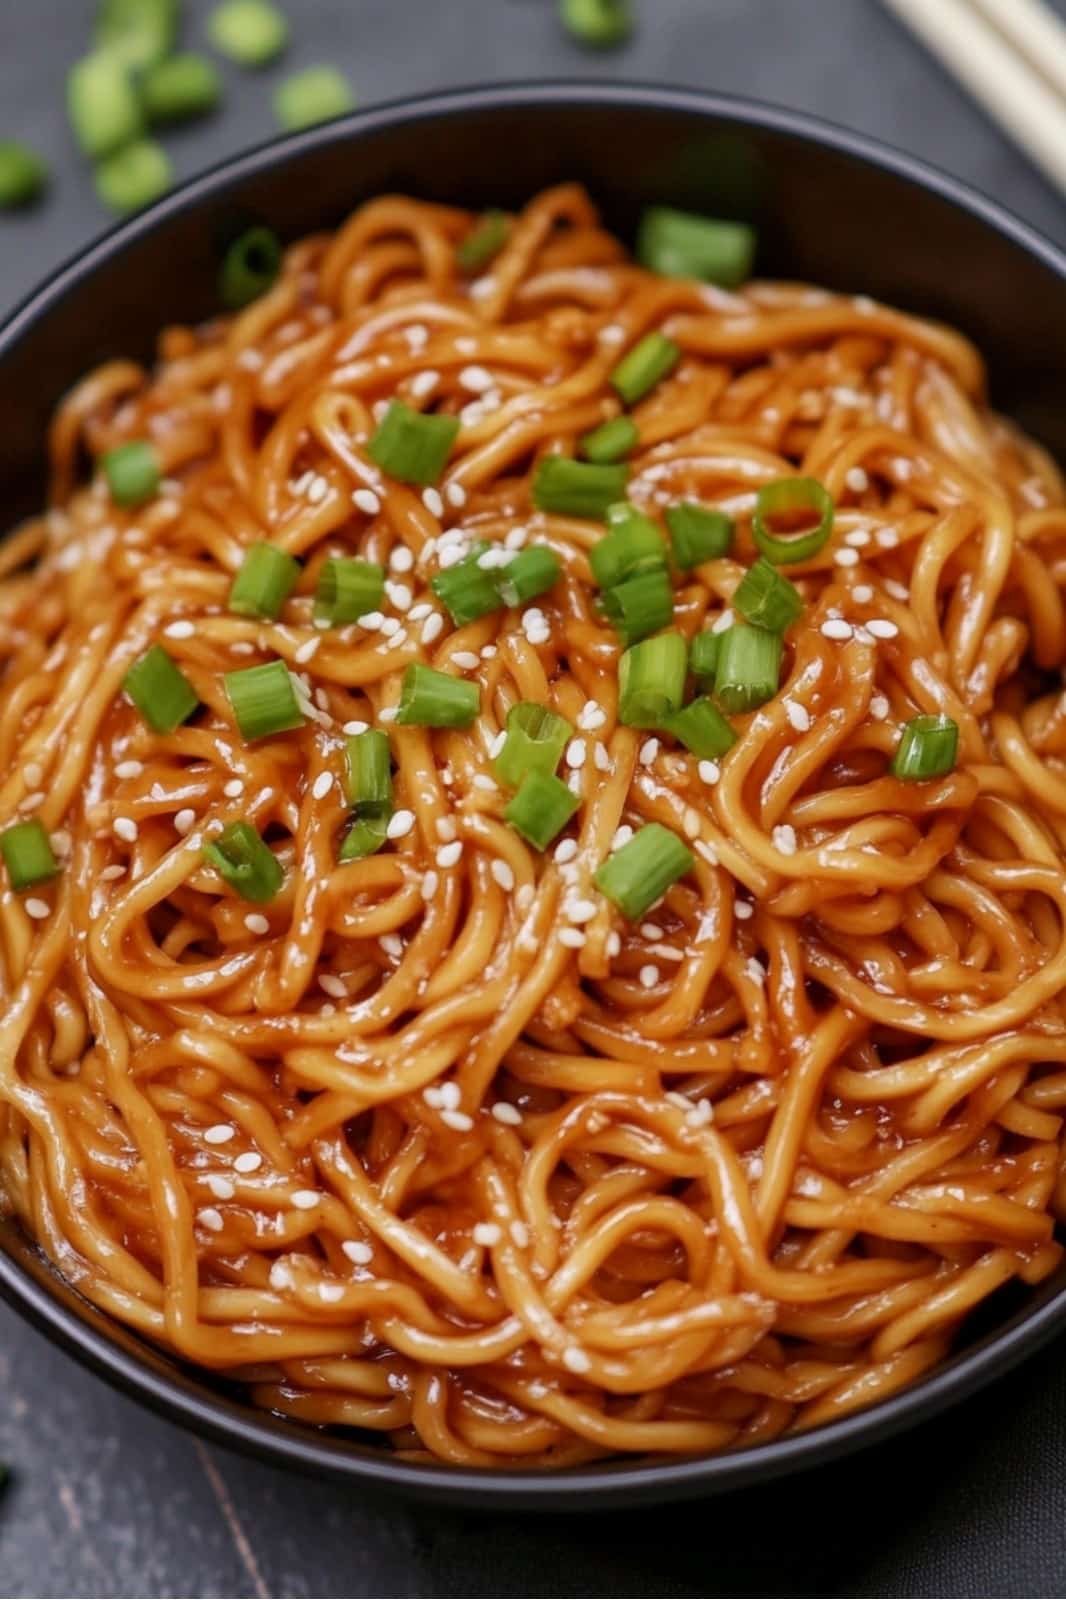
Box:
0;85;1066;1506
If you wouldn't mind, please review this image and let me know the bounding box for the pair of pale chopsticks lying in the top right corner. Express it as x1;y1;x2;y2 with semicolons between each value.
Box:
884;0;1066;192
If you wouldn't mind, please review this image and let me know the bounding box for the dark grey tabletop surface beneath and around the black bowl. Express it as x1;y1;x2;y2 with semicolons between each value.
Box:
0;0;1066;1597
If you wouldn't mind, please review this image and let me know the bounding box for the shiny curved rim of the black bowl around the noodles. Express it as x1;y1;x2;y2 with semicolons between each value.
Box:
0;78;1066;1510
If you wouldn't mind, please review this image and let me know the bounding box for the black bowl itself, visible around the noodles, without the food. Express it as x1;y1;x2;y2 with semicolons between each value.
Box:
0;83;1066;1510
